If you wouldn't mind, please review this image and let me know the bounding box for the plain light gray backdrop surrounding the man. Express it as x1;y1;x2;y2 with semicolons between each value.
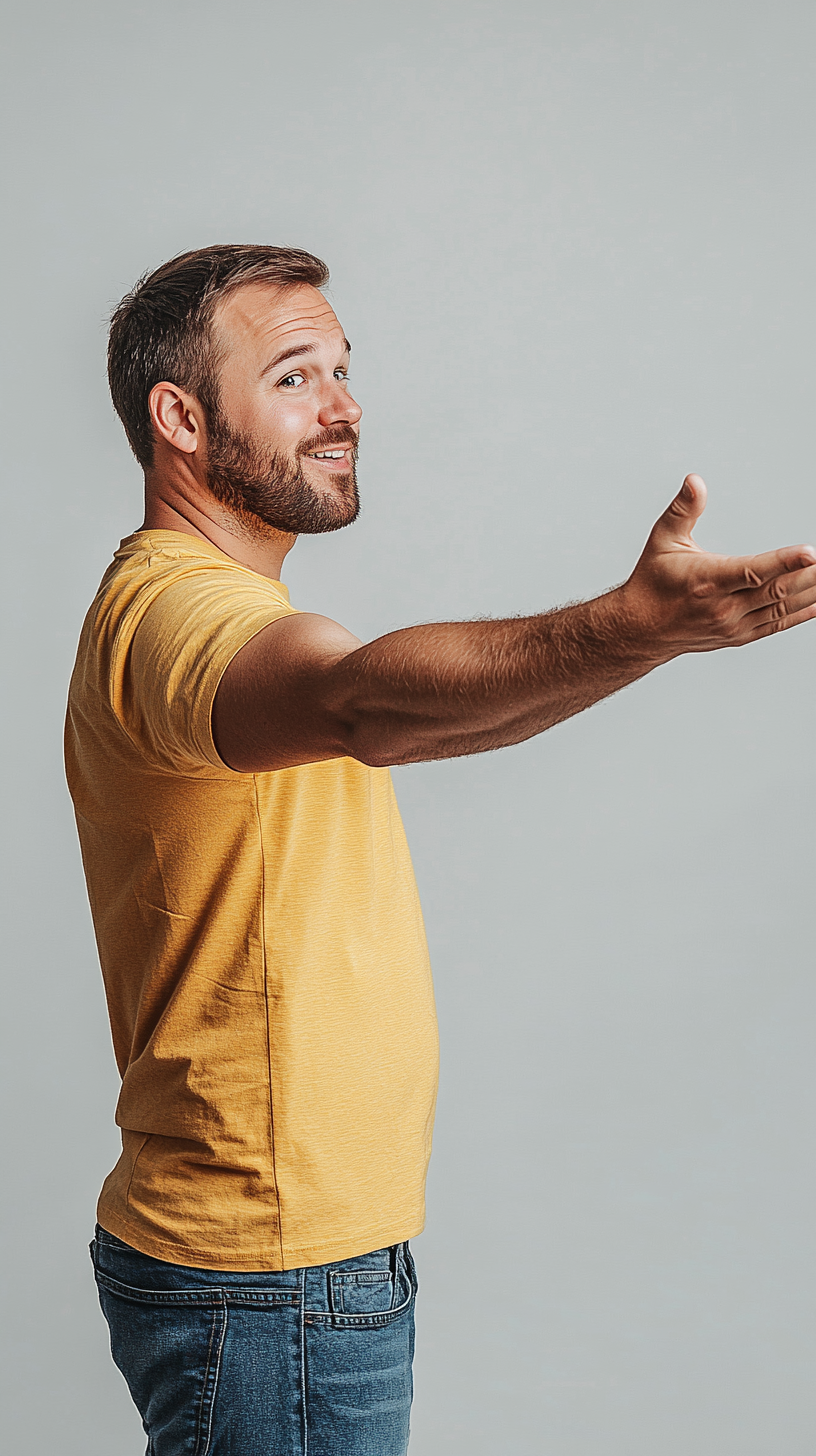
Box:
0;0;816;1456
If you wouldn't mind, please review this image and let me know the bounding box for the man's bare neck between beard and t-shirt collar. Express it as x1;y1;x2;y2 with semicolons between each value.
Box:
138;472;297;581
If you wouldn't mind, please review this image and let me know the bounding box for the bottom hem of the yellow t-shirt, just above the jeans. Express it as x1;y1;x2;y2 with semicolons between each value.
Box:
96;1207;425;1274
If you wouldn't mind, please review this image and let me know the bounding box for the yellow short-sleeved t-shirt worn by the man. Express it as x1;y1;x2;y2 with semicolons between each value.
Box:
66;531;437;1270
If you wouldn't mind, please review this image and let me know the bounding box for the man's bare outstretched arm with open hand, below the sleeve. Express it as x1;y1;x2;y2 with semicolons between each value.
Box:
213;475;816;772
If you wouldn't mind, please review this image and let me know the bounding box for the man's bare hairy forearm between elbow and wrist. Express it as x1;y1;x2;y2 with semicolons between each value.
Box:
326;588;672;764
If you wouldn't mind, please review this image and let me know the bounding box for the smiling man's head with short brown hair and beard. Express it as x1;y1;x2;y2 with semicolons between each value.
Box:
108;246;361;536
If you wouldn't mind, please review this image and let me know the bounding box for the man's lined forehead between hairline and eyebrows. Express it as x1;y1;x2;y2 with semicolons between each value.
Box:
213;284;344;354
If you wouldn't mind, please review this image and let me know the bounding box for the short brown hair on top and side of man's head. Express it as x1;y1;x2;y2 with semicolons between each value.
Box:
108;243;329;469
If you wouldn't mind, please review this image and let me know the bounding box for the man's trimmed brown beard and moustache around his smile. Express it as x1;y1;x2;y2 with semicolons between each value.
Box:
207;411;360;536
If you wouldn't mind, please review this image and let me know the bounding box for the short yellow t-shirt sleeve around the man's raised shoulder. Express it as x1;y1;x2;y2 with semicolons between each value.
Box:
111;566;294;773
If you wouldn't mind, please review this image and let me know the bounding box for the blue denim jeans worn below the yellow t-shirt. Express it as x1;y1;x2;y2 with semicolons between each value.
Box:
90;1227;417;1456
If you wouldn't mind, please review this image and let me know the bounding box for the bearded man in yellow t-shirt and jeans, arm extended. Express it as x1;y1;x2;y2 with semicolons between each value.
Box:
66;246;816;1456
